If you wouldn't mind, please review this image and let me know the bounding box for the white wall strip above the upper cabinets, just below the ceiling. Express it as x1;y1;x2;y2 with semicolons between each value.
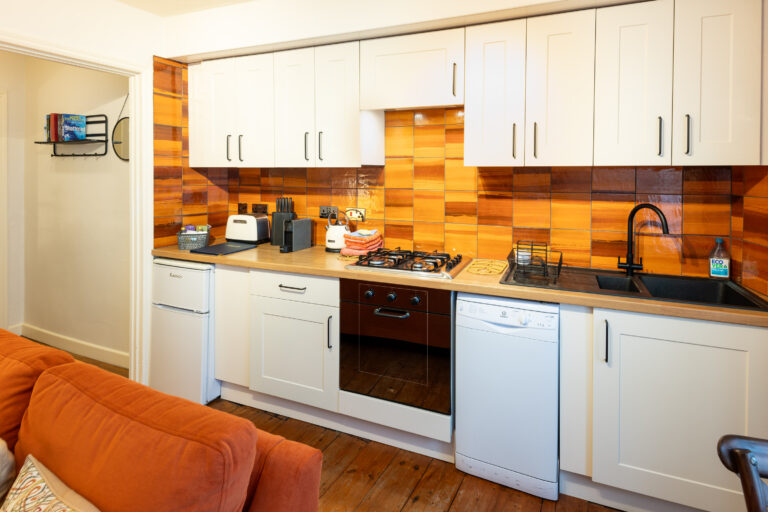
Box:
163;0;638;61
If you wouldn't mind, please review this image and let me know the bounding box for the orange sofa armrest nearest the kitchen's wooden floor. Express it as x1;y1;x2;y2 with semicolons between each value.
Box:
245;430;323;512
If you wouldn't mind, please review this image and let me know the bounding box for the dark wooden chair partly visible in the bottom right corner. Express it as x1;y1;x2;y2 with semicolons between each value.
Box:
717;436;768;512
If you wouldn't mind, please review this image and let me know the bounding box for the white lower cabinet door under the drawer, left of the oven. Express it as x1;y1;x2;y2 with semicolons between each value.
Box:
251;296;339;411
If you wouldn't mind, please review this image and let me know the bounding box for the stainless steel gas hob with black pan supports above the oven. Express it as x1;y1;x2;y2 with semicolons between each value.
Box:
346;249;470;279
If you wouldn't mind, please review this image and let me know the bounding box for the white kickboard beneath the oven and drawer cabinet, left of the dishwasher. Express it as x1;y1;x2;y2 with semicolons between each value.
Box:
221;382;453;462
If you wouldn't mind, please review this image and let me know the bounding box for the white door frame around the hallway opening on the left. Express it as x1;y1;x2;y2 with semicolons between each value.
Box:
0;33;154;384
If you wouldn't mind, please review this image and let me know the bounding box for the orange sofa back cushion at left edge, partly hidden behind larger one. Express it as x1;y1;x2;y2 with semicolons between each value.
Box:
0;329;74;450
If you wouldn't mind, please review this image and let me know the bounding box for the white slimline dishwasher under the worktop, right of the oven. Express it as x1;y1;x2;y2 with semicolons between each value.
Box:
455;293;560;500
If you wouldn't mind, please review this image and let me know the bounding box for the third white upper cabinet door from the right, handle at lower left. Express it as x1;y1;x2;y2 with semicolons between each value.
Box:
525;9;595;166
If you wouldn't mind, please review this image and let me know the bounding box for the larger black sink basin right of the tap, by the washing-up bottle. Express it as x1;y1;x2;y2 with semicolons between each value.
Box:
640;276;764;308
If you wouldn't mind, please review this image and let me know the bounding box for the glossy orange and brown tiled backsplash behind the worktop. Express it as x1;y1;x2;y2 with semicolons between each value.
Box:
155;58;768;294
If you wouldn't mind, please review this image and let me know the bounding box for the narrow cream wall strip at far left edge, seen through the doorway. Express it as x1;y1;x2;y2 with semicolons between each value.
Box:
0;51;26;333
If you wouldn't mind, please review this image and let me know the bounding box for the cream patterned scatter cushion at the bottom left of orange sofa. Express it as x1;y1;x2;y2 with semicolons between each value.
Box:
0;455;99;512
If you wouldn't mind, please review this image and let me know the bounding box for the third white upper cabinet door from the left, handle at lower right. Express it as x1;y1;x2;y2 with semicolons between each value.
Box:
275;48;317;167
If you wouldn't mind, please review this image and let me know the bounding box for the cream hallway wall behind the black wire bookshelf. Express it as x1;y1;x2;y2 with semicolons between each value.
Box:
23;58;131;366
